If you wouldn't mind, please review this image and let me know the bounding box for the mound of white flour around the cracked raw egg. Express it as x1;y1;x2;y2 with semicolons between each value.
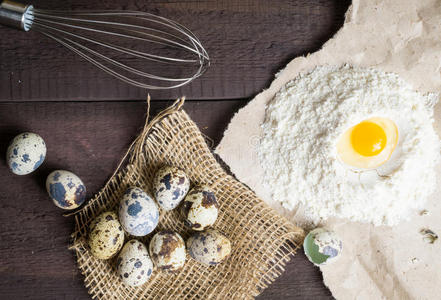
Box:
258;66;440;225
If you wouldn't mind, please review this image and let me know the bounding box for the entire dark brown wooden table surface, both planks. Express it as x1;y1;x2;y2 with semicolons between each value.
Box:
0;0;349;299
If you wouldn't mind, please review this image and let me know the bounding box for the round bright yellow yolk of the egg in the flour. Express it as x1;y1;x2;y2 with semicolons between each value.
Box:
351;121;387;156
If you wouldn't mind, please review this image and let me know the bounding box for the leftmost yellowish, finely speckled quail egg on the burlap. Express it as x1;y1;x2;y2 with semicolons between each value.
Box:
88;212;124;259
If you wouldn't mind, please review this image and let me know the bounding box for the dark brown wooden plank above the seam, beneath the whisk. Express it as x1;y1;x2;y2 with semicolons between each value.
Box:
0;0;350;101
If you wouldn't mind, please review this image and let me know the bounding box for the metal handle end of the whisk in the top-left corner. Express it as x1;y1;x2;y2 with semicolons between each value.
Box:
0;0;34;31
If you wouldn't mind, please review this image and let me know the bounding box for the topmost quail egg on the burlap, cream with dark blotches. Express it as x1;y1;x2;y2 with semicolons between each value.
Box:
153;166;190;210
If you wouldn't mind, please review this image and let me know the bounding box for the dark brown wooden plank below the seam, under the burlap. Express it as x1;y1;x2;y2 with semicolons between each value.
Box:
0;100;331;300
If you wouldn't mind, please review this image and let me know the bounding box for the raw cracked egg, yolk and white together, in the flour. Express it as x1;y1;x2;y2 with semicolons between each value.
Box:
337;117;398;169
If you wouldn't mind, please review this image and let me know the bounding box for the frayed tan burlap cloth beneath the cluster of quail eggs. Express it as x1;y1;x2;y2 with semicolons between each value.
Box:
71;99;303;299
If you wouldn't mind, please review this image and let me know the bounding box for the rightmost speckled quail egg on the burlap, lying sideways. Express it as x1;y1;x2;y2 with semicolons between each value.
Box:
187;229;231;265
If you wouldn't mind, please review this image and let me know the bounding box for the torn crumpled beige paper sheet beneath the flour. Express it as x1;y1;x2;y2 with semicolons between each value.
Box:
216;0;441;299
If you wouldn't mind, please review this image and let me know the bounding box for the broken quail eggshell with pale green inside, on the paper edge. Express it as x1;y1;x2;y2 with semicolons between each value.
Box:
303;228;343;266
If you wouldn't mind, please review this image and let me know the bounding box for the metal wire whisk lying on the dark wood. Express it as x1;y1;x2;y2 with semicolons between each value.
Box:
0;0;210;90
